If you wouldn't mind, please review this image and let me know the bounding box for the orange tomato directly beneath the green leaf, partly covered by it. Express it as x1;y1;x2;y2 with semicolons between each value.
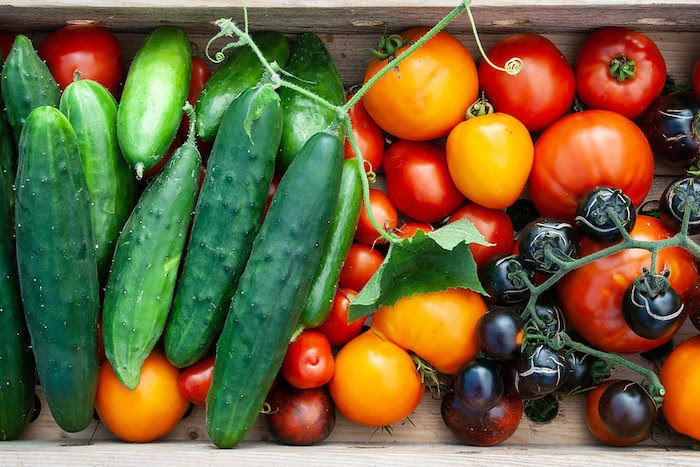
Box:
372;289;486;374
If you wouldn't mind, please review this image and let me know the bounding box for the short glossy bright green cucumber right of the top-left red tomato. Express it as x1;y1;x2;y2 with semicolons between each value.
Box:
117;26;192;179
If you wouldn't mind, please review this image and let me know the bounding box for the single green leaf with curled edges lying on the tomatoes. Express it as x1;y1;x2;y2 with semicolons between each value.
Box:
348;219;489;321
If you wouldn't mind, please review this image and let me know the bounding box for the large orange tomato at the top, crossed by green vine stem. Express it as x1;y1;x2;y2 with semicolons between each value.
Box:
362;27;479;141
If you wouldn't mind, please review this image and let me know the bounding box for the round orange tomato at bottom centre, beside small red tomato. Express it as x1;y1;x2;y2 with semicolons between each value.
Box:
328;330;425;426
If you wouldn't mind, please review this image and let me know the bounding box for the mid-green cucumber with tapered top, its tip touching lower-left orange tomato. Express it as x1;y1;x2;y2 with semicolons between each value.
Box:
102;143;201;389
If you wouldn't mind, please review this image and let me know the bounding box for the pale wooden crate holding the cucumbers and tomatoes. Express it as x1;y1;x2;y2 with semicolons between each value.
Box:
0;0;700;466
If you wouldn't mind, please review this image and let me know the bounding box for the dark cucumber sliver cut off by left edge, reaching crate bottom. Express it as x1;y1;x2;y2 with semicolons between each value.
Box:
0;170;34;441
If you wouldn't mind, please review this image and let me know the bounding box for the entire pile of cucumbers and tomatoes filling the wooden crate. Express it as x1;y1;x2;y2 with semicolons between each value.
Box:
0;2;700;454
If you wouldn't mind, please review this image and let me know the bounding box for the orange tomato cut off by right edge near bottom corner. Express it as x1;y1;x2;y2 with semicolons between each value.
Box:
659;336;700;440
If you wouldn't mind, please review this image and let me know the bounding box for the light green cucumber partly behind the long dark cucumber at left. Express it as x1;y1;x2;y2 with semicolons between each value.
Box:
59;80;136;284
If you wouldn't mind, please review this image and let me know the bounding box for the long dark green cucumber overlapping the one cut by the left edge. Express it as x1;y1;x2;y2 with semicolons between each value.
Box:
15;106;99;432
